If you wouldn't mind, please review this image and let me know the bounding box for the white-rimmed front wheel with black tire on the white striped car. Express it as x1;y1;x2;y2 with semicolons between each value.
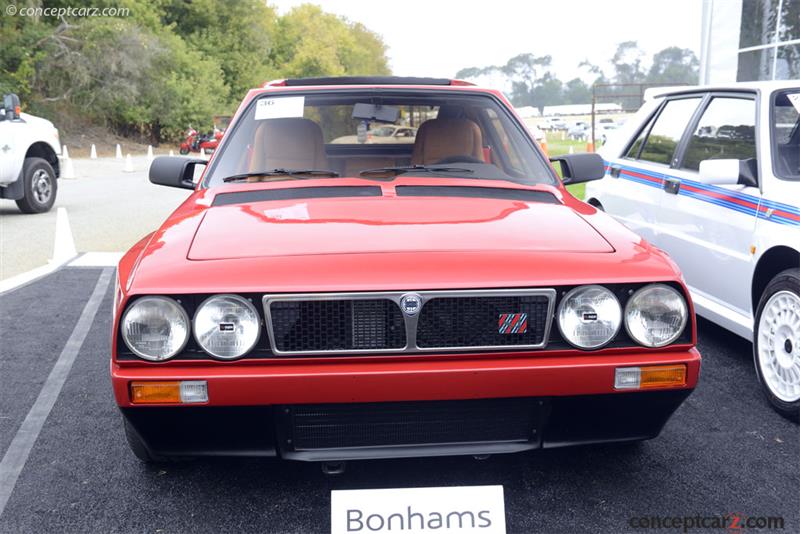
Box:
753;269;800;422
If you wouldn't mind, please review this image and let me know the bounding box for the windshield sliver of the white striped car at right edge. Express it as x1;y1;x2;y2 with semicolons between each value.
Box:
772;89;800;180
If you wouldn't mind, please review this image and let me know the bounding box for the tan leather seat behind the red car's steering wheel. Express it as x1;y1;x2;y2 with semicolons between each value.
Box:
411;118;483;165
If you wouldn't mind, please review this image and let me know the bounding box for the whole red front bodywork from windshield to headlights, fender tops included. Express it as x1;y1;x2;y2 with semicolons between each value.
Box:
119;182;680;294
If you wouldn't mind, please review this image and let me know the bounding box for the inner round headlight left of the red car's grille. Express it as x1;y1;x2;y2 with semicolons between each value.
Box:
194;295;261;360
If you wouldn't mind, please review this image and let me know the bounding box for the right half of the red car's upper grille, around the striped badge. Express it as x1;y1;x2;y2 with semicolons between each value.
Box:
417;295;550;348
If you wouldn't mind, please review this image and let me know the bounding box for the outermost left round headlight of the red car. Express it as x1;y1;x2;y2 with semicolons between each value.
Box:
121;297;189;362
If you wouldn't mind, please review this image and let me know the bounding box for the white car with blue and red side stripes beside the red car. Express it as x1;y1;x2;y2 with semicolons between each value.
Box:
586;80;800;420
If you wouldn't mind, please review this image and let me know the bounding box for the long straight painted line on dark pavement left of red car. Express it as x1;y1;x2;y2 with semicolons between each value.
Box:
0;269;114;516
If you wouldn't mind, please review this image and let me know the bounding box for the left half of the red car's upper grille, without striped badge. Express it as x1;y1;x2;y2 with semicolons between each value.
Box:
269;299;406;352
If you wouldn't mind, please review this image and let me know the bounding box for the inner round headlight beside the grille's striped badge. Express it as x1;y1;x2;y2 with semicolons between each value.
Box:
558;286;622;349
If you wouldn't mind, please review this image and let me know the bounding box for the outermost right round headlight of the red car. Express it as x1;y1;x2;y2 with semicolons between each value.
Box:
625;284;689;347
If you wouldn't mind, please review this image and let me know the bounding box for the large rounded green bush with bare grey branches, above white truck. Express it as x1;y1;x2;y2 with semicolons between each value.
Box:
3;13;228;141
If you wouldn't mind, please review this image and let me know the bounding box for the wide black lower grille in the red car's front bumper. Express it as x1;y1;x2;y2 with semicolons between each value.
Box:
284;398;539;451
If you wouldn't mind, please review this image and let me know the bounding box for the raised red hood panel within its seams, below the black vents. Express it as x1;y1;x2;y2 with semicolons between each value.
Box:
188;197;614;260
